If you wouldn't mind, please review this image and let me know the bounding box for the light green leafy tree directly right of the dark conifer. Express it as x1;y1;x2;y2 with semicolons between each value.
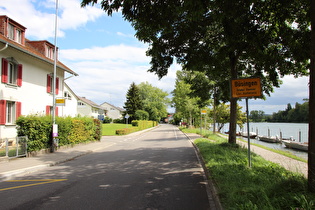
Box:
137;82;170;121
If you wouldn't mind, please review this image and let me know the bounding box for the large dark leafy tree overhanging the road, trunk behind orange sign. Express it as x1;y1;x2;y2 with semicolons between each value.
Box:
82;0;310;143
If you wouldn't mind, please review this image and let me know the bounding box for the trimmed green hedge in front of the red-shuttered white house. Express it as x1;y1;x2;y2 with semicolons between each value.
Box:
16;115;102;152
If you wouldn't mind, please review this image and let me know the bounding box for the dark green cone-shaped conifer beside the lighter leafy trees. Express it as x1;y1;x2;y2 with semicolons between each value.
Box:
124;82;143;121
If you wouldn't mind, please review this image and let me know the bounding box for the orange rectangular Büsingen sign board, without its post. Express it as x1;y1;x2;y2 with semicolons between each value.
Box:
231;78;261;98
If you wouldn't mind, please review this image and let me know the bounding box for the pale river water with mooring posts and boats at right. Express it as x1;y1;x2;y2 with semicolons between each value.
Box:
222;123;308;160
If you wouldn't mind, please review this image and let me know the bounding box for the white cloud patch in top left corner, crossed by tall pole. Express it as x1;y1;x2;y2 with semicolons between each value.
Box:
0;0;105;40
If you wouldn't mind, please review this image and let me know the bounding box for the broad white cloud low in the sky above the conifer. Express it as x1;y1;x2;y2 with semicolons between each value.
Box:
60;45;179;107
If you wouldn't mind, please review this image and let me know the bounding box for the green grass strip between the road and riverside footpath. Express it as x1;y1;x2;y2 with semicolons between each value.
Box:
183;129;315;210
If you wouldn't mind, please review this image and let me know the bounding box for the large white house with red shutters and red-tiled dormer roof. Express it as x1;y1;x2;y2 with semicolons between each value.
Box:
0;16;77;138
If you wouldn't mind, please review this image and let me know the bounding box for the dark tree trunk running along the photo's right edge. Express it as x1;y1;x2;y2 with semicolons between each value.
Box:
308;0;315;192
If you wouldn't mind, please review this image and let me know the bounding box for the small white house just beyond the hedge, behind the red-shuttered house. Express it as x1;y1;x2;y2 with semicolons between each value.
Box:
77;96;105;120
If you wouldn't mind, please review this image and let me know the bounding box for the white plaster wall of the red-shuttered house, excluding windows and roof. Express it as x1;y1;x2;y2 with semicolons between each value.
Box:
0;47;64;138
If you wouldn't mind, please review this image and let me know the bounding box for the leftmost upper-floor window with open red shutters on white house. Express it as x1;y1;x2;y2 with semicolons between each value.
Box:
1;58;23;87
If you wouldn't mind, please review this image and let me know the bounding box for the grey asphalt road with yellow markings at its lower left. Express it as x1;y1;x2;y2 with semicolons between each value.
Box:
0;125;210;210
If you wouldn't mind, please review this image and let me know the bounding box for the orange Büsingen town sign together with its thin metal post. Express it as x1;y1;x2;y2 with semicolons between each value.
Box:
231;78;261;167
